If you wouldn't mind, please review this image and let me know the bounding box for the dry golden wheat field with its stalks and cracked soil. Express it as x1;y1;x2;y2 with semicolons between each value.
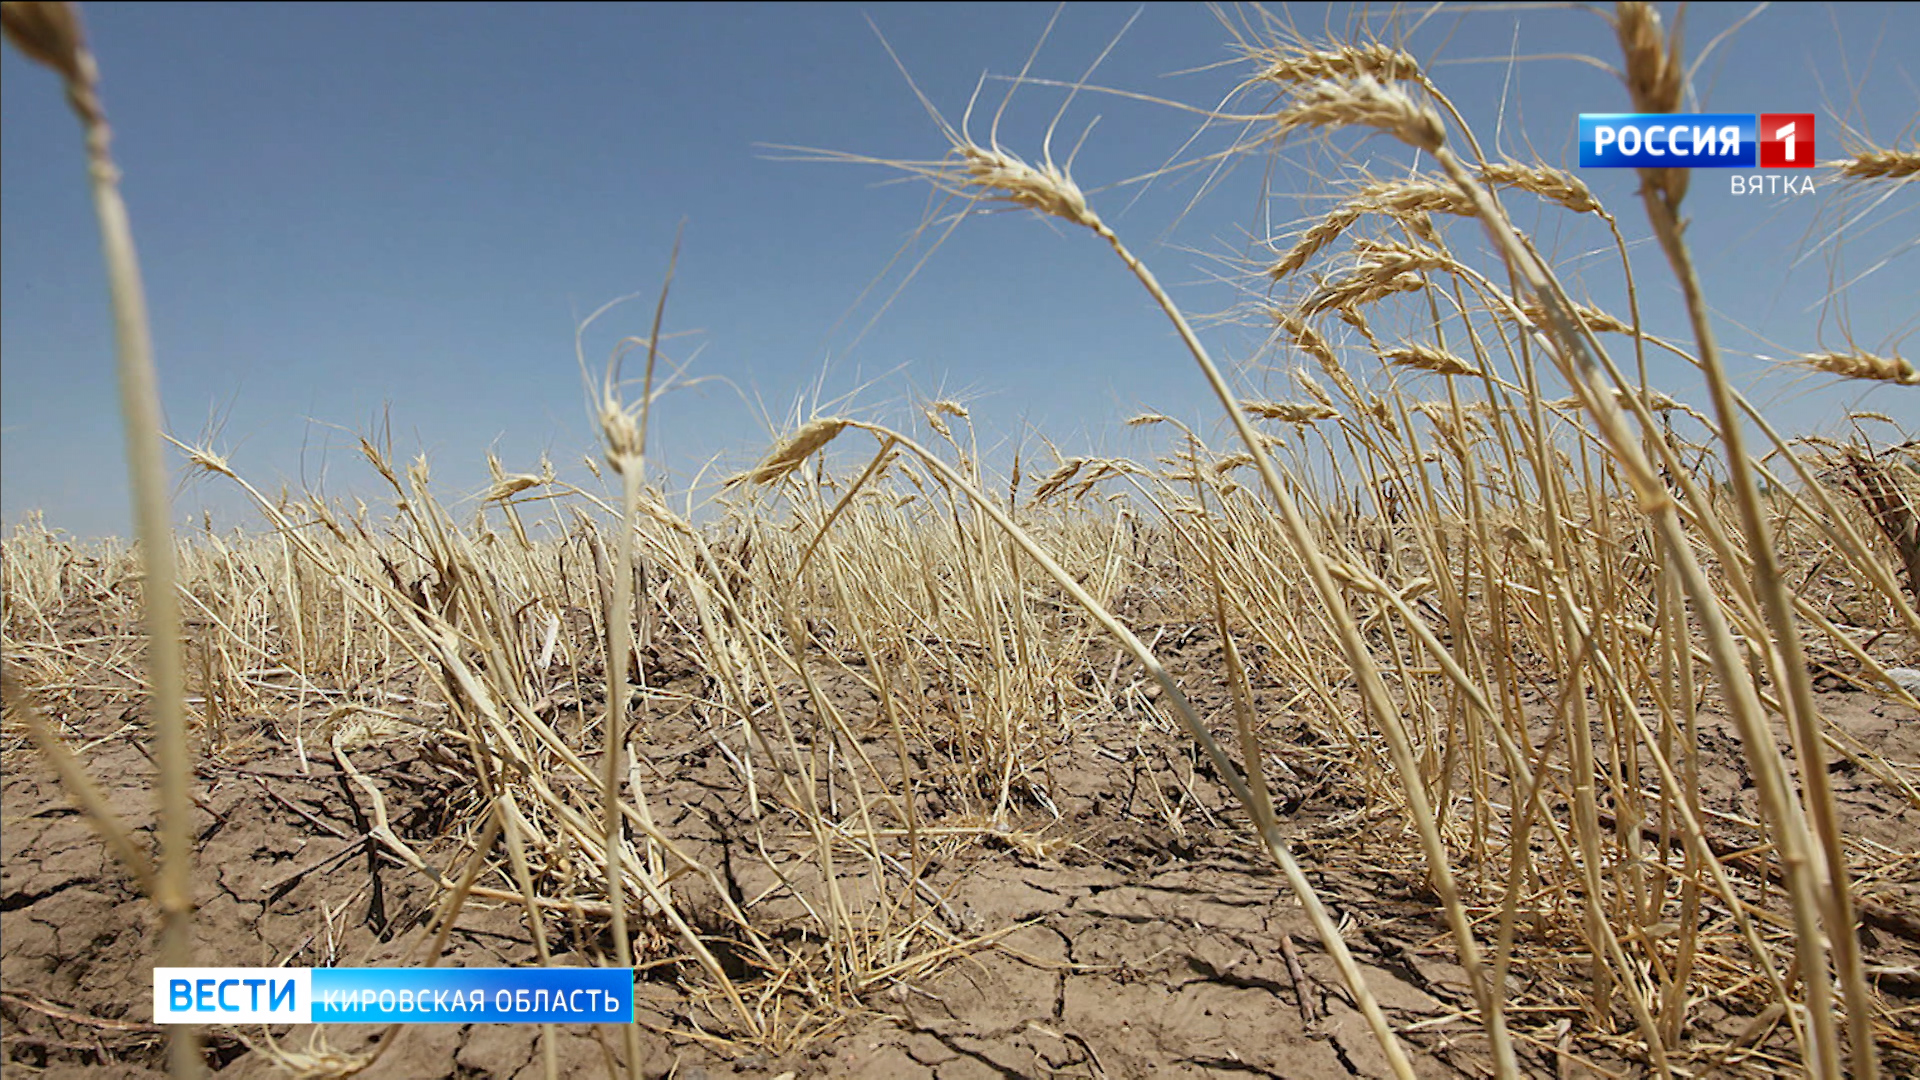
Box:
11;4;1920;1080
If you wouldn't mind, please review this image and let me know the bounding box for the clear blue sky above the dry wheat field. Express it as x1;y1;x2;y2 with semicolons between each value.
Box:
0;4;1920;536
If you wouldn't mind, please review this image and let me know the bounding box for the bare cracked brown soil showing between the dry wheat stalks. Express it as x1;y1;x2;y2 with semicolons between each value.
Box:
0;614;1920;1080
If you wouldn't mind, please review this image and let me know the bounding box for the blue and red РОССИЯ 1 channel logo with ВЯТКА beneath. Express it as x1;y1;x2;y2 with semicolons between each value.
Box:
1580;113;1816;194
